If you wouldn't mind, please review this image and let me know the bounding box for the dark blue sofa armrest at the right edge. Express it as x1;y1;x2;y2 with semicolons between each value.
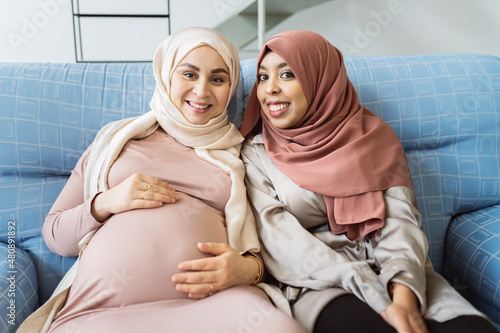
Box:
443;205;500;323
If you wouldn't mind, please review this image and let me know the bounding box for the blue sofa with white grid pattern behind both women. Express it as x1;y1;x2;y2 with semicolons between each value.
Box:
0;54;500;332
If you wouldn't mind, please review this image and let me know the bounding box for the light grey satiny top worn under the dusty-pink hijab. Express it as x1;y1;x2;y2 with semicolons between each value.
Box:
242;134;483;332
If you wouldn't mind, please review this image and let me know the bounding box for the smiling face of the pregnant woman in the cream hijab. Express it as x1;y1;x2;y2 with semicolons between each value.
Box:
170;46;230;125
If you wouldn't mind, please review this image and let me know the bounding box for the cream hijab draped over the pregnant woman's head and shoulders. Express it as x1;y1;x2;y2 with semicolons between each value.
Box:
81;28;259;253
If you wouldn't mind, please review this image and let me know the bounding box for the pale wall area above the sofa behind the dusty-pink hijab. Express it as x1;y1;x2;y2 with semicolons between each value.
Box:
245;0;500;56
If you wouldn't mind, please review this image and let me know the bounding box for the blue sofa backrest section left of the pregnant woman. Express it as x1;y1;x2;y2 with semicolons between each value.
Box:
0;63;155;302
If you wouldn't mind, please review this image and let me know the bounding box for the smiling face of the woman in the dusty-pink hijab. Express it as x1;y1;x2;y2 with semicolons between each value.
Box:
257;51;307;128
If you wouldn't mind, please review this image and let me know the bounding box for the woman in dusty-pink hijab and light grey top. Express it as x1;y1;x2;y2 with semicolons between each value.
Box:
241;30;496;333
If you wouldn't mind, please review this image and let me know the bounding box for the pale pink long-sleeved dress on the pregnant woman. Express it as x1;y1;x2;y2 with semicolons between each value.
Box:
44;129;303;333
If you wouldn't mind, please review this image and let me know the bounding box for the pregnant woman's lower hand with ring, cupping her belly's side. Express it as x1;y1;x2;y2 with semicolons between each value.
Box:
172;243;259;298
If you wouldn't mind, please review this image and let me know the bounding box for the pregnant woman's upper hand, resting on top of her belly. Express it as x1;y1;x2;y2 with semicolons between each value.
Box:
92;173;180;222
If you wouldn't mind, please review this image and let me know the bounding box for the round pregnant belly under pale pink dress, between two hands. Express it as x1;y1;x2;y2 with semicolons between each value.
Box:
70;196;227;310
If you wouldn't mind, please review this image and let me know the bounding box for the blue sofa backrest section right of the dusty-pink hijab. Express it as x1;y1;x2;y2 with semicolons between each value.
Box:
346;54;500;271
